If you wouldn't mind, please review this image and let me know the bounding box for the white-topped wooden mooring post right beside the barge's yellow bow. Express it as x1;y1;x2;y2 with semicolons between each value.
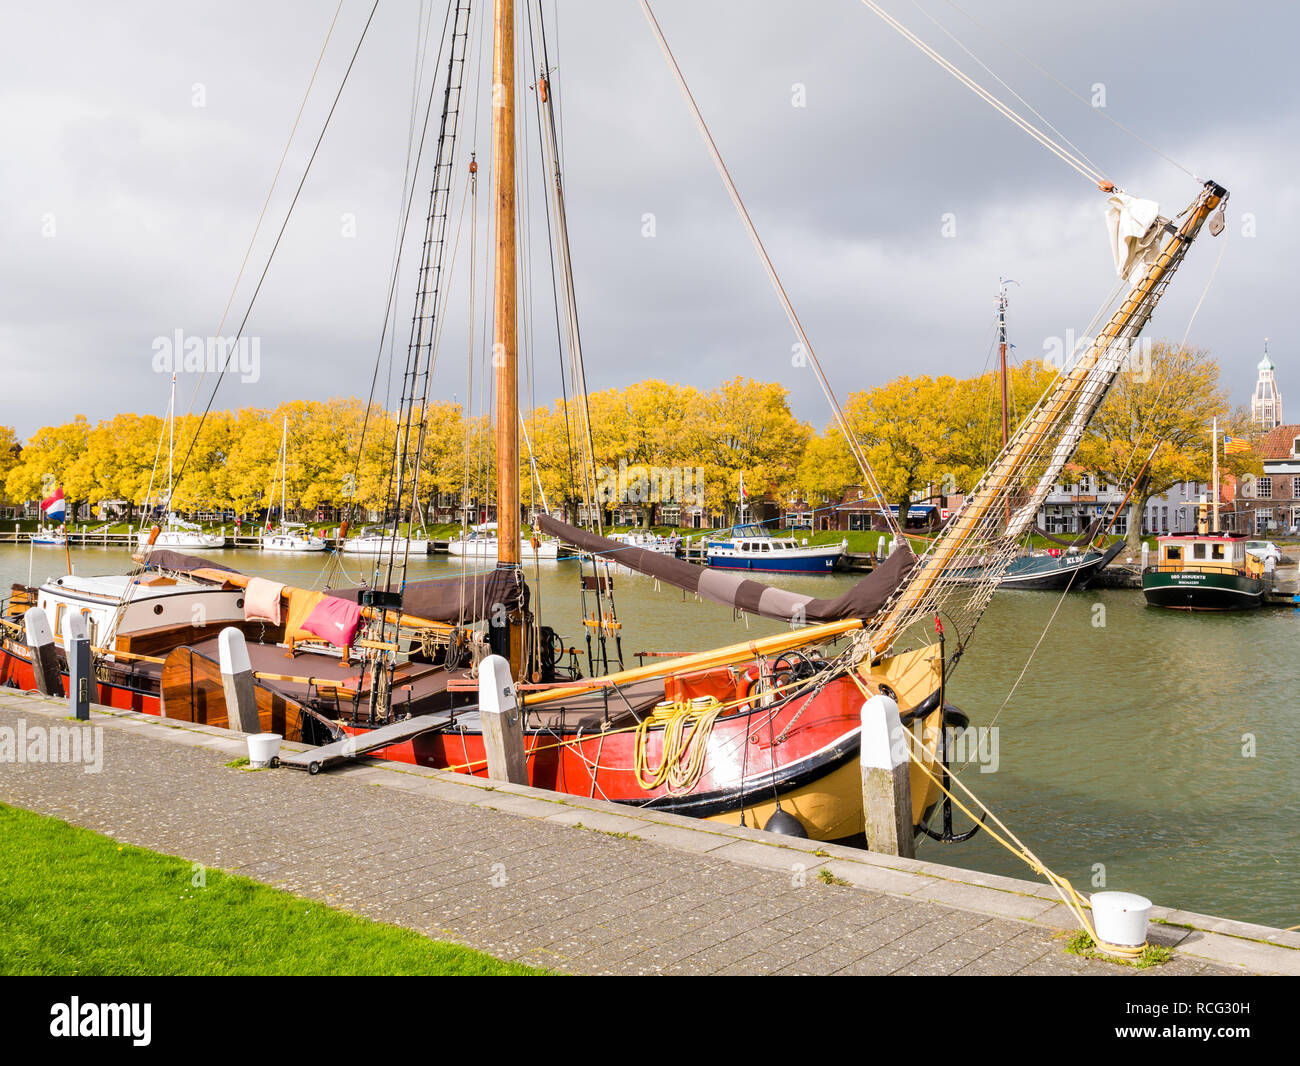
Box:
861;696;917;859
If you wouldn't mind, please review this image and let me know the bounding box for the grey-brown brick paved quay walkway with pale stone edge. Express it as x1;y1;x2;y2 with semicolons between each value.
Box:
0;693;1300;975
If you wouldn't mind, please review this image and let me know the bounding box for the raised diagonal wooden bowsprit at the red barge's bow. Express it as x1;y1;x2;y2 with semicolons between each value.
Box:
871;182;1227;654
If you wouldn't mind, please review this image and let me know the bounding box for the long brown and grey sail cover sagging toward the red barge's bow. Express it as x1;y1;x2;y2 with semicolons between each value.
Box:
537;515;917;623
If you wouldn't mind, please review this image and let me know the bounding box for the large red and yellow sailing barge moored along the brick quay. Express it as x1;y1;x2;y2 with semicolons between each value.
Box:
0;0;1227;840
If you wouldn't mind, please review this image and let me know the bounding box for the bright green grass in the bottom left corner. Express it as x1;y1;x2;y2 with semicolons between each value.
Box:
0;805;543;976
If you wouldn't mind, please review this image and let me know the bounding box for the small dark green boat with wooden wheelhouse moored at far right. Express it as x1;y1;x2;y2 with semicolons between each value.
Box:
1141;533;1268;611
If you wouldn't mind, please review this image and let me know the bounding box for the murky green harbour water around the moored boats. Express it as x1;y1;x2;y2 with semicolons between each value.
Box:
0;546;1300;927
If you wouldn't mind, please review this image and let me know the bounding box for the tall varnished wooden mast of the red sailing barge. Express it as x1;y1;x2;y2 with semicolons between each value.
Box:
491;0;524;677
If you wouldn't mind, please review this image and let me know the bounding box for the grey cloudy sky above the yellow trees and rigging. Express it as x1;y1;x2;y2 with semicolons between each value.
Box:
0;0;1300;437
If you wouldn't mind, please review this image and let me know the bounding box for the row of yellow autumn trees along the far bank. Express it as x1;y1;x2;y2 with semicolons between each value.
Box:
0;342;1257;540
